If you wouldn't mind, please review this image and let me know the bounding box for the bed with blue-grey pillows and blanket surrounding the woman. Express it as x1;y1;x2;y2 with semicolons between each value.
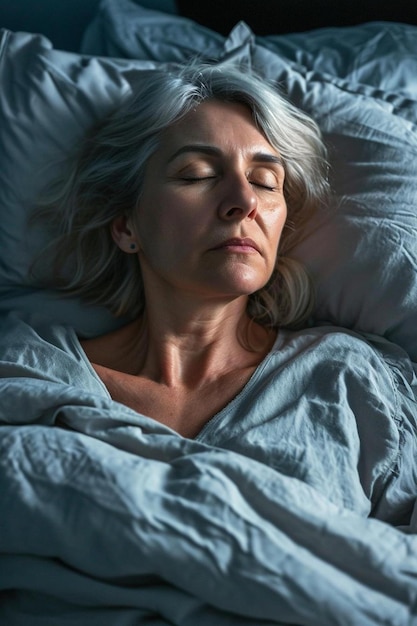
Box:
0;0;417;626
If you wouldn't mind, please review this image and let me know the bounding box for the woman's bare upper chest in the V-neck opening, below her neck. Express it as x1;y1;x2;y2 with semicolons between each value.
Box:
94;365;255;438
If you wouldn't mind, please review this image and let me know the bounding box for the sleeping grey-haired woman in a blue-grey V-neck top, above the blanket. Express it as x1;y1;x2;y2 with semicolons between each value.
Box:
5;64;417;528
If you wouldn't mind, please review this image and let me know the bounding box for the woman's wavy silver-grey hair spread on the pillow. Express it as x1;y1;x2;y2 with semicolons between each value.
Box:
38;63;328;327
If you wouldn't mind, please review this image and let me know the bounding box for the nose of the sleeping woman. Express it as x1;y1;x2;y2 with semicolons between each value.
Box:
218;176;258;220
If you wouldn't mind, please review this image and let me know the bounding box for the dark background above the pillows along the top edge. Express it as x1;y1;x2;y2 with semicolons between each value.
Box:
0;0;417;51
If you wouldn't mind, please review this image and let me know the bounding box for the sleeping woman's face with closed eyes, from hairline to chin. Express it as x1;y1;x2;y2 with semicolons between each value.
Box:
125;101;287;299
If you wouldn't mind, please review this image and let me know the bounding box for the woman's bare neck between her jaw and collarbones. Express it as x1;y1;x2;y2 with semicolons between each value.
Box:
132;296;273;388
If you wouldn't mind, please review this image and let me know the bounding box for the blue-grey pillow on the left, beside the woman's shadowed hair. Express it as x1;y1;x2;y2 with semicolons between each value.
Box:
0;30;158;335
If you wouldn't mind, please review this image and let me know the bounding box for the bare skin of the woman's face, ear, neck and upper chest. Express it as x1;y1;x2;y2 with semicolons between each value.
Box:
83;101;287;436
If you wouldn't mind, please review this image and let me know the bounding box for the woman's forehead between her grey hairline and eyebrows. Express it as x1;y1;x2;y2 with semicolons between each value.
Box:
160;100;277;154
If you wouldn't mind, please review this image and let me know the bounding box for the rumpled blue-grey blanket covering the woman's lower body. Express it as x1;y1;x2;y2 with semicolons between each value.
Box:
0;314;417;626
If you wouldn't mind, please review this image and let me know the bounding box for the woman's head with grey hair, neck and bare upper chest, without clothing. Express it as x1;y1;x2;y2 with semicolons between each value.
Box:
36;61;327;436
